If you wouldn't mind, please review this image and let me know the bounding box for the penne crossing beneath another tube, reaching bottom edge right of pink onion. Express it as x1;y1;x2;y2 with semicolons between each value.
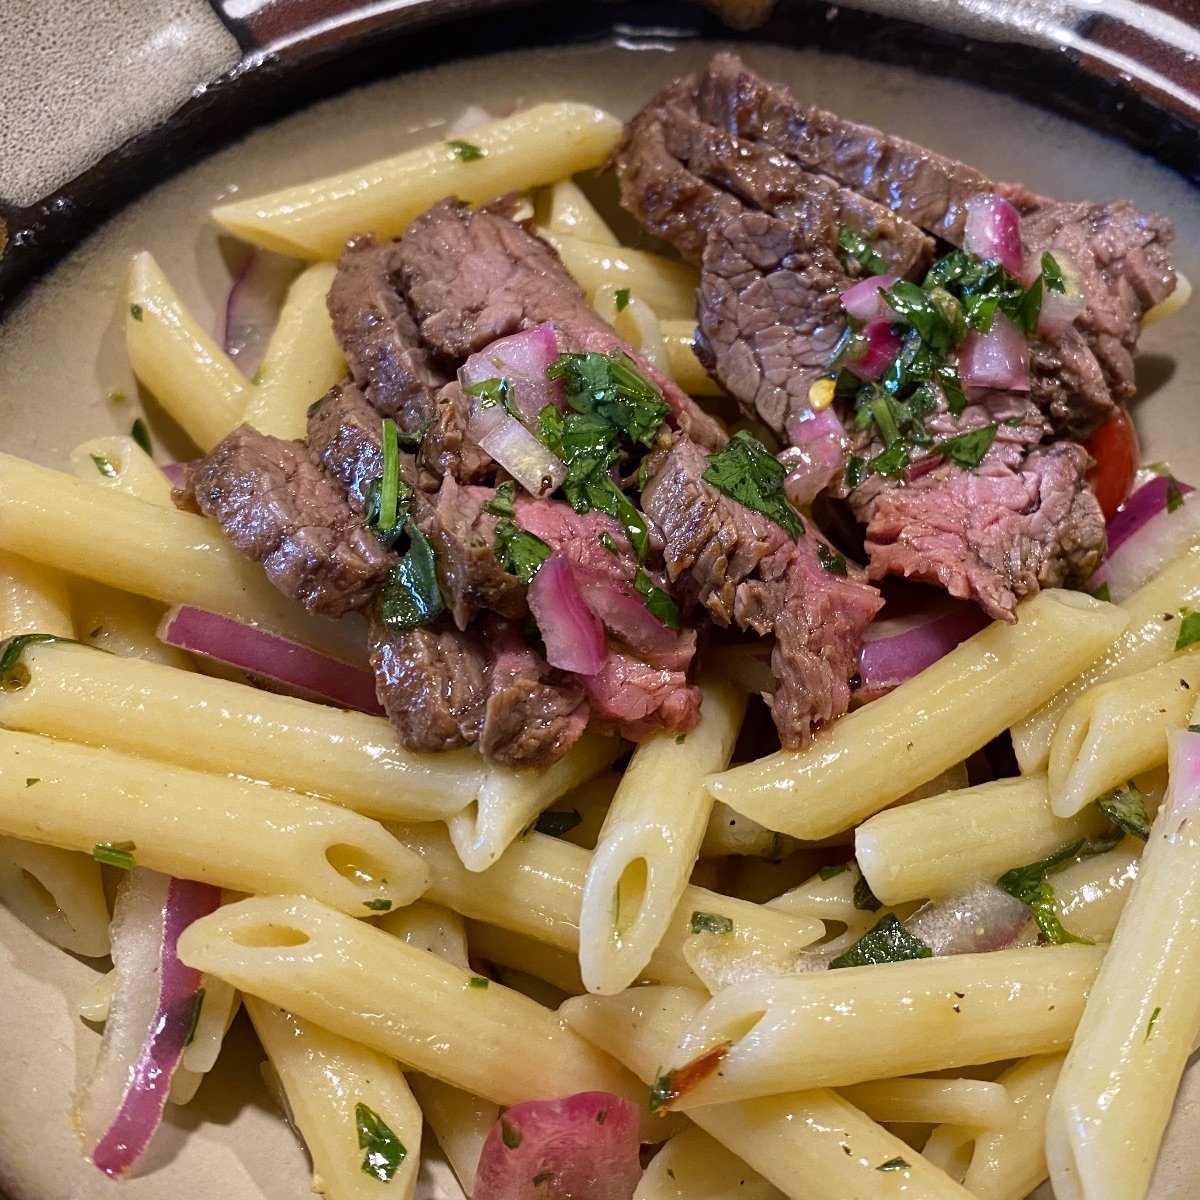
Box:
562;988;968;1200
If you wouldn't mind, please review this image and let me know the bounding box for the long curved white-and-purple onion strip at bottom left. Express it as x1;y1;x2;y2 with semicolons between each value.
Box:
77;866;221;1178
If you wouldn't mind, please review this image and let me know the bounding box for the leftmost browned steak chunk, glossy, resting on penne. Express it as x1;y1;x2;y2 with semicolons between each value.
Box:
186;425;396;617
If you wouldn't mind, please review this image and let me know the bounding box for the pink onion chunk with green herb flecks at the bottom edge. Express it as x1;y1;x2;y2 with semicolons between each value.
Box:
474;1092;642;1200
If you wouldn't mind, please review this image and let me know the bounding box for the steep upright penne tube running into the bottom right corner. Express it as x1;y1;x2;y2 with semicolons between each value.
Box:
1046;713;1200;1200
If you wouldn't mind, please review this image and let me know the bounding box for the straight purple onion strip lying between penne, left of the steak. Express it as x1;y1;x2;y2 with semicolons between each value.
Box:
158;605;383;715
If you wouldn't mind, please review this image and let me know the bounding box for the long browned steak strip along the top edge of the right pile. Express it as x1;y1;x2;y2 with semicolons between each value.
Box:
696;54;996;246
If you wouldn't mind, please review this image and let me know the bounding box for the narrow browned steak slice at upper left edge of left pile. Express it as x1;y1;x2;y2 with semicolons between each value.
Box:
329;234;450;433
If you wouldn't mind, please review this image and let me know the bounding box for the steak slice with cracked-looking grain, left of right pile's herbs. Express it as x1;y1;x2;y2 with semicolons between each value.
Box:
696;204;850;442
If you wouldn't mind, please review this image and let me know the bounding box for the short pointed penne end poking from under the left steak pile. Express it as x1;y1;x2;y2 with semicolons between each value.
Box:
446;730;624;871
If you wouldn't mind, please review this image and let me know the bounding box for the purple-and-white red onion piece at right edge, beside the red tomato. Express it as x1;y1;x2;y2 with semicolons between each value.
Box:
1087;475;1200;604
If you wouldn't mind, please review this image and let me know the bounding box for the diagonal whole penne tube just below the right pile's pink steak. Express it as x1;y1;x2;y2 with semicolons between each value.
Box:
708;588;1128;839
